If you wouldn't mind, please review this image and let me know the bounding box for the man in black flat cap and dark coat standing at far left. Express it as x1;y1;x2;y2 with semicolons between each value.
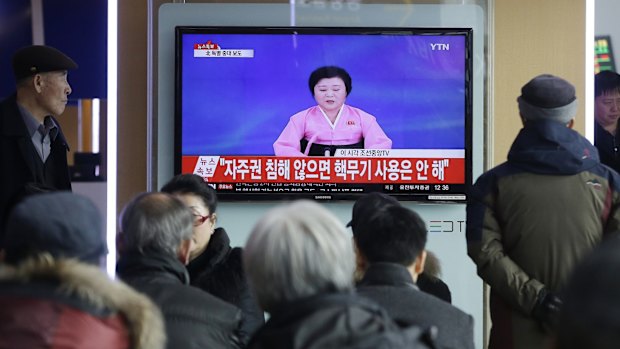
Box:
0;45;77;245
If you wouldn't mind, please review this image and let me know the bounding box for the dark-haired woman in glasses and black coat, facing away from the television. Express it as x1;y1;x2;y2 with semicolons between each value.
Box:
161;174;265;340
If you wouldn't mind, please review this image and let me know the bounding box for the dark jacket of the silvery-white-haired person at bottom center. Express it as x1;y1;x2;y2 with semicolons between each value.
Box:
248;294;432;349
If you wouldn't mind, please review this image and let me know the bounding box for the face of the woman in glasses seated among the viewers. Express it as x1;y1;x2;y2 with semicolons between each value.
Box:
175;193;216;260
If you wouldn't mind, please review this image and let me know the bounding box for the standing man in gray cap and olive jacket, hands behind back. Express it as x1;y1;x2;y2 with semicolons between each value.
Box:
466;74;620;349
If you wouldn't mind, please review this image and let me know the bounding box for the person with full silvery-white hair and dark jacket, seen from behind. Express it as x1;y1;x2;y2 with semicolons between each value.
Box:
243;200;430;349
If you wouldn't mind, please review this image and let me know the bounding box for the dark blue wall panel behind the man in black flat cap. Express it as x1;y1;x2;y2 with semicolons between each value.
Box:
0;0;107;103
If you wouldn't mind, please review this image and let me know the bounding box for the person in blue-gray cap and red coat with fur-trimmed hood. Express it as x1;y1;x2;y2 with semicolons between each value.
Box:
0;192;165;349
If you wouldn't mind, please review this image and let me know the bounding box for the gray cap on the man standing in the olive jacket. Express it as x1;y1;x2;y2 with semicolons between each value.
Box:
517;74;577;124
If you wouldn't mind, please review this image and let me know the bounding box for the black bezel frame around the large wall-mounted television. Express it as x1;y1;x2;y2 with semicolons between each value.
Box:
173;25;473;204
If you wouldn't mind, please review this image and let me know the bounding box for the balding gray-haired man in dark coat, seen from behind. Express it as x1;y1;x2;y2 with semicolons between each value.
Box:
116;193;241;349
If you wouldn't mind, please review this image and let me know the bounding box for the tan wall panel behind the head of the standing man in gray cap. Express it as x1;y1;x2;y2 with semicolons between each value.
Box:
489;0;586;164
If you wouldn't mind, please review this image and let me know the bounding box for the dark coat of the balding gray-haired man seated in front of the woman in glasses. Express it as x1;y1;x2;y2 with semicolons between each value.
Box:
116;252;241;349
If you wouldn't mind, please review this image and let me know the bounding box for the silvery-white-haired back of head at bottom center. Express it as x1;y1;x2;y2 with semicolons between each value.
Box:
243;200;355;311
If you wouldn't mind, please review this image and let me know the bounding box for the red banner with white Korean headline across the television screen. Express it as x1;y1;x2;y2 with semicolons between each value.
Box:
182;149;465;184
